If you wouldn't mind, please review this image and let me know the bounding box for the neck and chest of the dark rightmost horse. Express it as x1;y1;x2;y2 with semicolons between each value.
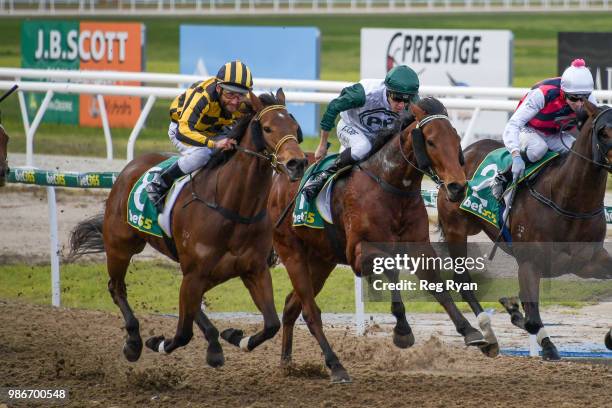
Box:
552;126;608;212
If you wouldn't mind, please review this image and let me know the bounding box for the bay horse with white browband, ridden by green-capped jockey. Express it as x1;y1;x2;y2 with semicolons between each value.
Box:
268;98;485;382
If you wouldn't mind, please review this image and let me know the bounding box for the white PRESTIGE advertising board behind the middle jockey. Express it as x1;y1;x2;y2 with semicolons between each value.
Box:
361;28;513;136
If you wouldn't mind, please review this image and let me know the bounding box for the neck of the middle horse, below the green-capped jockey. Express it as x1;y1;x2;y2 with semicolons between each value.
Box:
364;128;423;191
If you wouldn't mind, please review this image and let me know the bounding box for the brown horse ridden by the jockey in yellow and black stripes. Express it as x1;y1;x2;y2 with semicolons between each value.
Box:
72;89;306;367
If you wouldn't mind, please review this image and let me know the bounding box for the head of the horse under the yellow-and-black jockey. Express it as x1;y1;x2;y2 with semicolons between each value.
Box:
249;88;308;181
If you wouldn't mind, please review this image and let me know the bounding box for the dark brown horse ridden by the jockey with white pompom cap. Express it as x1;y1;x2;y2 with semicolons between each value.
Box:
438;102;612;360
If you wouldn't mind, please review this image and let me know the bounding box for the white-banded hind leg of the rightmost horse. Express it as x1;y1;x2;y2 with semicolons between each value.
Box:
446;236;499;357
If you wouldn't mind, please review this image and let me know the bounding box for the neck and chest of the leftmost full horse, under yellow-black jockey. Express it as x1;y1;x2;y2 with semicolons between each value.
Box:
198;126;272;217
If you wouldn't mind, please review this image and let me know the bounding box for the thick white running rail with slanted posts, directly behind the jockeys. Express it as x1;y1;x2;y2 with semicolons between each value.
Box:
0;68;612;166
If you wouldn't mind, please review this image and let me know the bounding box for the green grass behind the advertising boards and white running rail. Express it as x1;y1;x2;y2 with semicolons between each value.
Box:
0;12;612;158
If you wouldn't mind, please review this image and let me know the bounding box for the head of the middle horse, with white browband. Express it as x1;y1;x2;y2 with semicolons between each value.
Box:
407;97;466;202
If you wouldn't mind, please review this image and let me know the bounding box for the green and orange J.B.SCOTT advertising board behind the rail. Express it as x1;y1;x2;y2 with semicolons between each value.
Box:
21;21;145;127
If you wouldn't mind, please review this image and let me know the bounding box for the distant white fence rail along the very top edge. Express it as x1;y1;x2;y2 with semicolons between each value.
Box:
0;0;610;17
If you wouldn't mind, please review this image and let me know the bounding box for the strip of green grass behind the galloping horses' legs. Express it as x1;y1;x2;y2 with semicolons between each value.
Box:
0;261;612;314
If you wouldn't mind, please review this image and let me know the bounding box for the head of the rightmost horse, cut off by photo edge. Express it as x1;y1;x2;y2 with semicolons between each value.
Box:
577;101;612;172
